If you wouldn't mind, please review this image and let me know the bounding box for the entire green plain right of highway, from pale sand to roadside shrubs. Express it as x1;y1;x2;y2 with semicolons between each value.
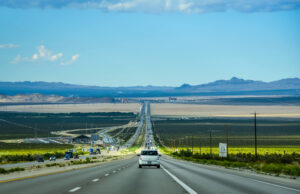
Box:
153;119;300;176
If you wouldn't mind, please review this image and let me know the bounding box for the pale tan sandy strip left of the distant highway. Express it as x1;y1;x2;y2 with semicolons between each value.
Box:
0;103;141;113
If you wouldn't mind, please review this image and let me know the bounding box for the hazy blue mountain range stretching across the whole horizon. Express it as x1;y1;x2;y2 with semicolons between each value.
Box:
0;77;300;97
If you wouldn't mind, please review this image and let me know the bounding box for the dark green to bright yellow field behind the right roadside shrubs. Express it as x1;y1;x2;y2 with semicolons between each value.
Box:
153;118;300;154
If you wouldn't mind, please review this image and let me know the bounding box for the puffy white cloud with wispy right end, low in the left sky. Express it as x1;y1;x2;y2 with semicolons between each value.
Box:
11;45;80;65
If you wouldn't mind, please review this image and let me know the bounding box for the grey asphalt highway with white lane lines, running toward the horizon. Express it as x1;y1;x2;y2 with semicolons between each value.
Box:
0;104;300;194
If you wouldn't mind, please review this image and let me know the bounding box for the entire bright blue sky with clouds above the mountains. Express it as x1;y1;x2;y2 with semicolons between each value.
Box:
0;0;300;86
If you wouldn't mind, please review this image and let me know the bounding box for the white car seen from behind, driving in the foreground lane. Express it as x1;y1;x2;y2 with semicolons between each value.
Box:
138;150;161;168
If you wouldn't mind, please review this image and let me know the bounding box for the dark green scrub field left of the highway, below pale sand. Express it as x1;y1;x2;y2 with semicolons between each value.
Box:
0;112;136;140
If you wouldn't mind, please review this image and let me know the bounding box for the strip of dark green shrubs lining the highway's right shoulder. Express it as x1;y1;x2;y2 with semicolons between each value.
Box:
169;150;300;176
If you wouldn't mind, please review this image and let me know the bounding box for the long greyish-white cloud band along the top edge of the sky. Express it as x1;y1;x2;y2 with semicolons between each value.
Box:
0;0;300;13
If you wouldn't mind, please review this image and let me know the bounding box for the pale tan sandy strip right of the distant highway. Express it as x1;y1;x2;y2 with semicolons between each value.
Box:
151;103;300;118
